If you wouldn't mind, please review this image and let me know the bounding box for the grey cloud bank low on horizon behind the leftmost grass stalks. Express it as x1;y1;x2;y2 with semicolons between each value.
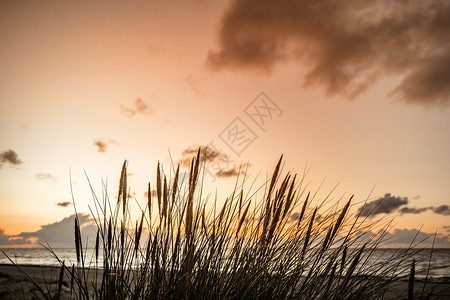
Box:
14;214;96;248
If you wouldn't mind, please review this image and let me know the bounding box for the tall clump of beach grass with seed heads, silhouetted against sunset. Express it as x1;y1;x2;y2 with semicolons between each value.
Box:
11;150;432;299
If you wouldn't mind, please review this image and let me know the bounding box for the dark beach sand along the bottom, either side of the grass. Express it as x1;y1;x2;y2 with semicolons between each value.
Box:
0;264;450;300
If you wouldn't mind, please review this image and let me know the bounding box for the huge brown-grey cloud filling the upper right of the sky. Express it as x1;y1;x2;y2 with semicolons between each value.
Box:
207;0;450;105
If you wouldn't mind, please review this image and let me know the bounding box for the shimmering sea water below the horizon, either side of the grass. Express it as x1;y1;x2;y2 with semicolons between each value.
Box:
0;248;450;280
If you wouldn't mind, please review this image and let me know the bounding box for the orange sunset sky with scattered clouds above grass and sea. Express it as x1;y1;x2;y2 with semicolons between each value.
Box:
0;0;450;247
